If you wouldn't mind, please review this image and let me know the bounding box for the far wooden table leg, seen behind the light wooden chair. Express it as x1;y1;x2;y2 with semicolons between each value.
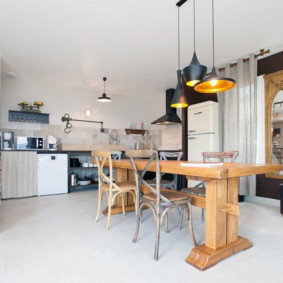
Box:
102;168;135;215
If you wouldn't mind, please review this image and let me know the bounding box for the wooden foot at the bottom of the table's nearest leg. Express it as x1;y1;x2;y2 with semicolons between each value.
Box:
186;237;253;271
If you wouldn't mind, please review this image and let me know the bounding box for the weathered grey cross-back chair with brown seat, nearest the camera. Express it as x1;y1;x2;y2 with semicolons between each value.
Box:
126;150;196;260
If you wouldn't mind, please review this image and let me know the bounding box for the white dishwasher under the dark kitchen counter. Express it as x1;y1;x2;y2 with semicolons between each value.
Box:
37;153;68;196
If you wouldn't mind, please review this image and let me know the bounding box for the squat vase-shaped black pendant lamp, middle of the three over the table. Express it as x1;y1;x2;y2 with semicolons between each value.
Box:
183;0;207;86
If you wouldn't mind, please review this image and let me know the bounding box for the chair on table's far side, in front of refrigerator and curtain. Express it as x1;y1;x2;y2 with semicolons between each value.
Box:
182;151;239;225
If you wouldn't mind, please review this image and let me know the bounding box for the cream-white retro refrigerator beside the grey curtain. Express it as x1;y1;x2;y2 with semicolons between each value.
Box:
188;101;219;186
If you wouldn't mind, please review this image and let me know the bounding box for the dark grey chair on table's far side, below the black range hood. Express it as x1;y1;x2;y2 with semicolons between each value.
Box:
147;151;183;191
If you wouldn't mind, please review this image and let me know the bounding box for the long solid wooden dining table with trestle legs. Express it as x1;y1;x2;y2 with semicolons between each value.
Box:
105;160;283;271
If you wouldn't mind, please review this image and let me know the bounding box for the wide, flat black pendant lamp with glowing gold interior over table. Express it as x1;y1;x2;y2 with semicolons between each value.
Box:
194;0;236;93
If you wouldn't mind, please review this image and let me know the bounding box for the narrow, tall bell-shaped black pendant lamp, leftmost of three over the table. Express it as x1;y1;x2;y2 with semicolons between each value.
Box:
171;1;188;108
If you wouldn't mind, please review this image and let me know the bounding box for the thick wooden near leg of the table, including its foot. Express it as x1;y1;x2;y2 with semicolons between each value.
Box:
186;178;252;271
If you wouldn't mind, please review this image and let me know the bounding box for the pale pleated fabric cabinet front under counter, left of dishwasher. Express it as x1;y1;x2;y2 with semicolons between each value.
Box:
1;151;37;199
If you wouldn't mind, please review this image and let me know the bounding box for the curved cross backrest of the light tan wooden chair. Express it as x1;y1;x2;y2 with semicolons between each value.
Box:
91;150;115;190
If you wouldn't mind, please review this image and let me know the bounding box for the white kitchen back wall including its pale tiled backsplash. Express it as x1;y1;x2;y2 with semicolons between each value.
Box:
0;69;182;149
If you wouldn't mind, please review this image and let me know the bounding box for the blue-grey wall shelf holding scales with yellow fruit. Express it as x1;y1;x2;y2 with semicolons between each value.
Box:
8;110;49;124
